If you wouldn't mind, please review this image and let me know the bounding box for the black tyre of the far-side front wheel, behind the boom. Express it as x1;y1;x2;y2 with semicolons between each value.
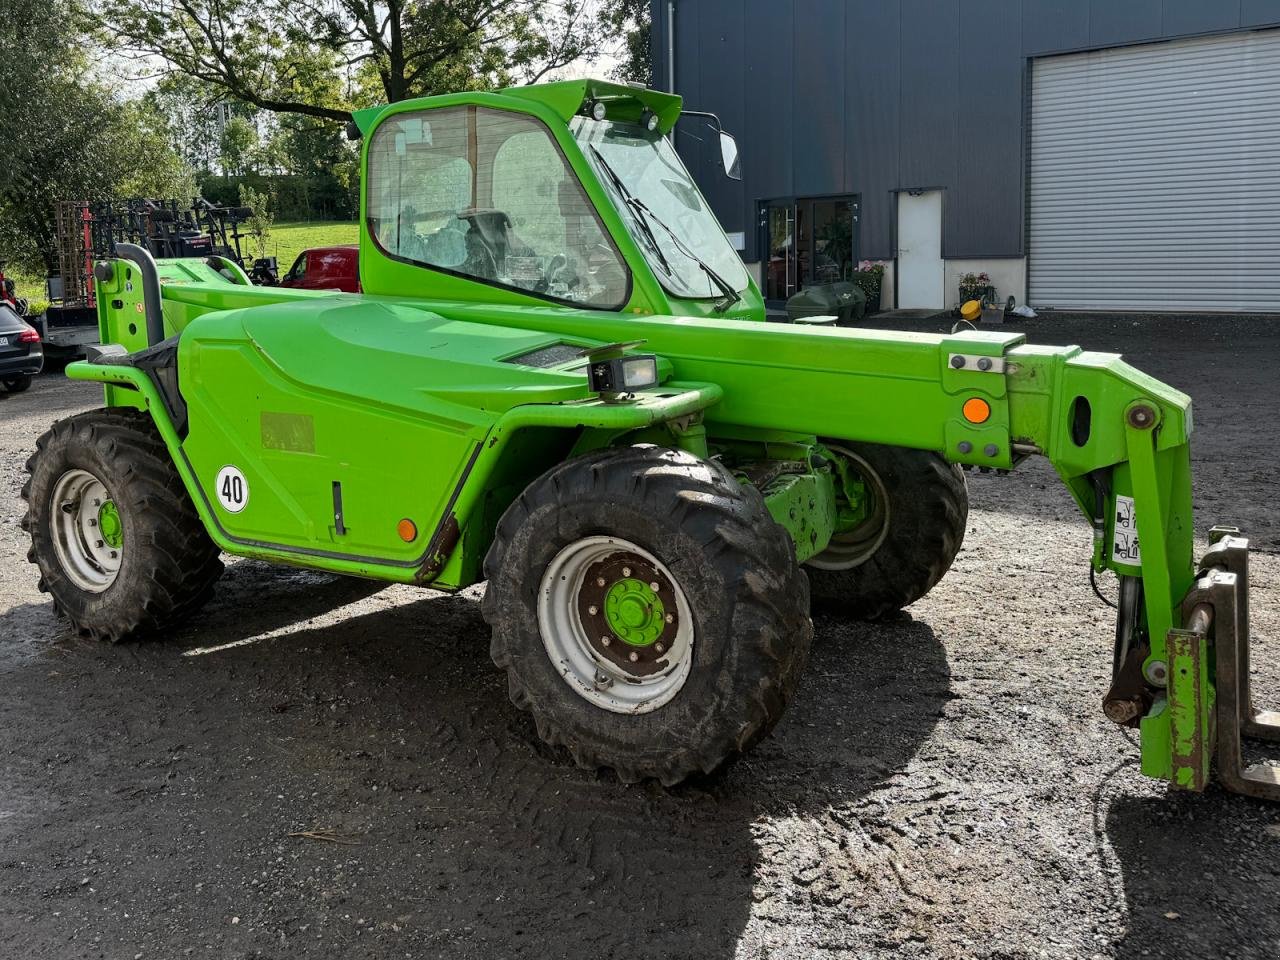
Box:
808;440;969;620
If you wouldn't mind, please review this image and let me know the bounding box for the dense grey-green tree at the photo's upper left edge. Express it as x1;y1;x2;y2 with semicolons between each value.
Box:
0;0;193;271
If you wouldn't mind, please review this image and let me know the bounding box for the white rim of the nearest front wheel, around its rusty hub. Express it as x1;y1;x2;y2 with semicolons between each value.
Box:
538;536;694;714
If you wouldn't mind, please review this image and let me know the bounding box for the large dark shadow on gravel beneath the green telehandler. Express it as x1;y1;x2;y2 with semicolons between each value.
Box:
0;570;951;960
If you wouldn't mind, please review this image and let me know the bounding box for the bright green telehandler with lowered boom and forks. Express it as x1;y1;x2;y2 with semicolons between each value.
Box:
23;81;1280;799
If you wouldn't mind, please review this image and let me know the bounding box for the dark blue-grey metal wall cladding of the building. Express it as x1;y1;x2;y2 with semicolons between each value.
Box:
653;0;1280;260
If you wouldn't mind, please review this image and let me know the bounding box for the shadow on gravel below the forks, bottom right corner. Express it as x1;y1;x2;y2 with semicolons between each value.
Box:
1106;787;1280;957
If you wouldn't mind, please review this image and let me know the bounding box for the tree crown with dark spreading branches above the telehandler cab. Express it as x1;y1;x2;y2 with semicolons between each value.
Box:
102;0;604;120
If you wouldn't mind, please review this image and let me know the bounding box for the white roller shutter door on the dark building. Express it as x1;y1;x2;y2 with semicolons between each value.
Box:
1028;31;1280;312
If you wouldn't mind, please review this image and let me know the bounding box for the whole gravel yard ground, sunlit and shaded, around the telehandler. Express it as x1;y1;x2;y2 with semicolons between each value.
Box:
0;316;1280;960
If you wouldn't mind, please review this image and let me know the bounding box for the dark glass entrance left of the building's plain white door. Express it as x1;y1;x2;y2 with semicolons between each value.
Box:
760;197;858;308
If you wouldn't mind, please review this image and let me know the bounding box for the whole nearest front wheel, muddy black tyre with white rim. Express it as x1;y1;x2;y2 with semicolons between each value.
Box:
484;447;813;785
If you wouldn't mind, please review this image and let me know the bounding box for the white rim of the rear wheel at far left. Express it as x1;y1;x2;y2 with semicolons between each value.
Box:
49;470;124;594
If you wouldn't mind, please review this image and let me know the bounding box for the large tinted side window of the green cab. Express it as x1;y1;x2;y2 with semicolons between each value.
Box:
367;106;630;310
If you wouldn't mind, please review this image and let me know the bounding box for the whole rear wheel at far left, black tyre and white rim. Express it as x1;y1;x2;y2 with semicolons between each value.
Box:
22;408;223;643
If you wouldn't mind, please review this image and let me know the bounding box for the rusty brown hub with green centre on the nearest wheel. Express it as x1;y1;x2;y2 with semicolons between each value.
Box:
577;552;680;677
